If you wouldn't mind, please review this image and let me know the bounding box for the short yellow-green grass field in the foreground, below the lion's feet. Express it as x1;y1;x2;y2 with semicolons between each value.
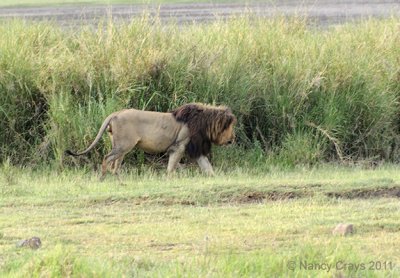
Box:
0;163;400;277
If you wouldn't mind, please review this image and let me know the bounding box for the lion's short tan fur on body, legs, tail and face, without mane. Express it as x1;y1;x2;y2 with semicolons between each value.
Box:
66;104;236;180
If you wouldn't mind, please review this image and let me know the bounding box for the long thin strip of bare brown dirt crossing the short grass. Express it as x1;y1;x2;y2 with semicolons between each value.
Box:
77;185;400;207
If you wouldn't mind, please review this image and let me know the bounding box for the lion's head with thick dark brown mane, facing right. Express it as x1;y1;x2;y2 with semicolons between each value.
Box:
172;103;236;158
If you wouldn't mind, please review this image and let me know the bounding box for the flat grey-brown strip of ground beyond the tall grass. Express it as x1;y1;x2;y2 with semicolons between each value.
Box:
0;0;400;26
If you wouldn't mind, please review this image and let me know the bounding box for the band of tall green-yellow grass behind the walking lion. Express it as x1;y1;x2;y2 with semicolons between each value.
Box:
0;16;400;165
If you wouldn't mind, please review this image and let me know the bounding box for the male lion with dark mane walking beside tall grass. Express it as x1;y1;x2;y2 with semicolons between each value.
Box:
65;103;236;180
